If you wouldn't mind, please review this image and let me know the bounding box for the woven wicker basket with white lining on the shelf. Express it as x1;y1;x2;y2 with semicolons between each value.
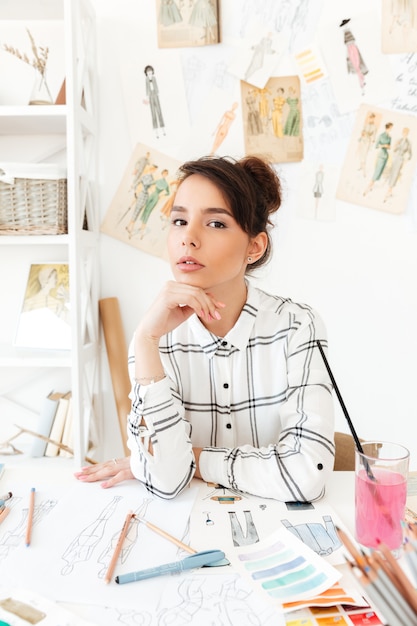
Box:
0;163;68;235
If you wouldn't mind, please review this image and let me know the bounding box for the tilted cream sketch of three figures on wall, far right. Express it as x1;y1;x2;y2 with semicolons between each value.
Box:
337;105;417;214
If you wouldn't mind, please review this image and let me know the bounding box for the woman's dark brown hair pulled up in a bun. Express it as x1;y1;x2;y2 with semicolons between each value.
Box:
174;156;282;271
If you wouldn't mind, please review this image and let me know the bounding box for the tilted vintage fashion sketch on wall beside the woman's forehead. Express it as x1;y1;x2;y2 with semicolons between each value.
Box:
101;144;180;258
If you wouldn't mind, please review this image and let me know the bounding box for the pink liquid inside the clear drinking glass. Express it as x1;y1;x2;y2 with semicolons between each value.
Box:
355;469;407;550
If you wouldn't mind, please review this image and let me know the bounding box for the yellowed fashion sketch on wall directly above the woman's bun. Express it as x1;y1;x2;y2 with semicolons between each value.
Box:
241;76;304;163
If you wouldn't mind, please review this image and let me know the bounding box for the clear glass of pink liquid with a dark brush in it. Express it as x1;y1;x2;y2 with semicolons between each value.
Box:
355;441;410;556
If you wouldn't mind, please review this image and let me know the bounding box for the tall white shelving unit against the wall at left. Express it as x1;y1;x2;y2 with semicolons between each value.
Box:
0;0;99;464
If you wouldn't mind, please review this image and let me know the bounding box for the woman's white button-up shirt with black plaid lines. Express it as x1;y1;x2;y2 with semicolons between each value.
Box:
128;283;335;501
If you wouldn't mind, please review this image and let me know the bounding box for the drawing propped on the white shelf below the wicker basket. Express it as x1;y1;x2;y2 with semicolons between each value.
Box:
15;263;71;350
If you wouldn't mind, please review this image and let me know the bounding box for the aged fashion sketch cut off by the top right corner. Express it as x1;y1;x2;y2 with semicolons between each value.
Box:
381;0;417;54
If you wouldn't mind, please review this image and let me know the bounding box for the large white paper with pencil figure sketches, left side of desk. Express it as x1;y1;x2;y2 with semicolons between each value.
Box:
0;481;197;608
